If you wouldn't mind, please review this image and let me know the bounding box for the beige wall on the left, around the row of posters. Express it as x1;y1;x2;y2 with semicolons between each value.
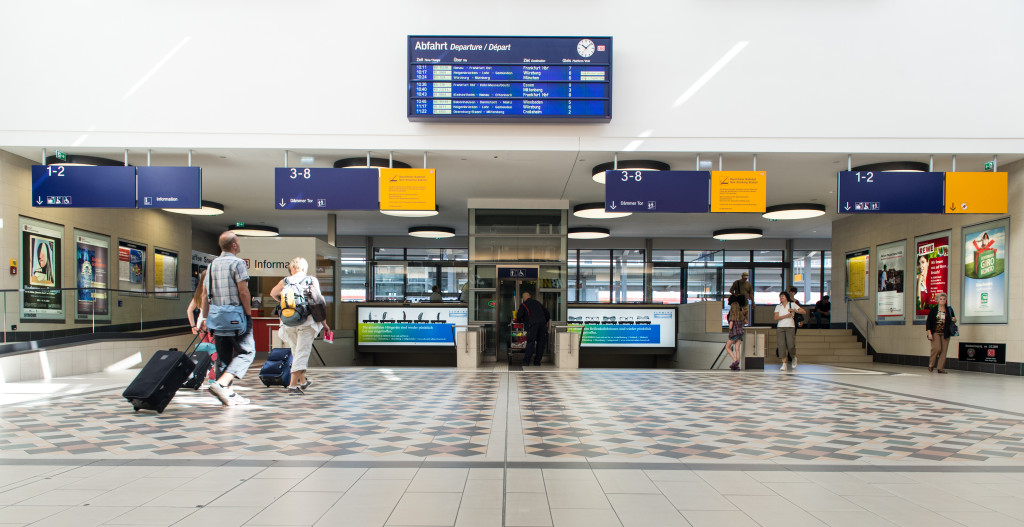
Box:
0;150;193;332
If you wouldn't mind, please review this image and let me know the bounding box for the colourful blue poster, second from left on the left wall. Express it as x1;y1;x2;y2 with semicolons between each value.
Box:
75;229;111;322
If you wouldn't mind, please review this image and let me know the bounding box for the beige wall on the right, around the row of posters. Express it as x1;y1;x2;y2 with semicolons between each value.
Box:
831;162;1024;362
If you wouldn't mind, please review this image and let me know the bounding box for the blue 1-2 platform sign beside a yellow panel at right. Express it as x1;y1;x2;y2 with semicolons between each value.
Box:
838;171;945;214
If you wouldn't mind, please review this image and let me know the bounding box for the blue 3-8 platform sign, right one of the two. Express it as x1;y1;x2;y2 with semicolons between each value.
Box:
604;170;711;212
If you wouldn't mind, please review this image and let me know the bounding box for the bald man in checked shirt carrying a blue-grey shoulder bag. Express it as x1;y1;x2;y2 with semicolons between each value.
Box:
202;230;256;406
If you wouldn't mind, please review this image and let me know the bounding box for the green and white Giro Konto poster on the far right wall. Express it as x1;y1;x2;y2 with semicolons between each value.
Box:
961;219;1010;323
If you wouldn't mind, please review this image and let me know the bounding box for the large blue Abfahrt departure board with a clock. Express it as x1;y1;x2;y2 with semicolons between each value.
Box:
407;36;611;123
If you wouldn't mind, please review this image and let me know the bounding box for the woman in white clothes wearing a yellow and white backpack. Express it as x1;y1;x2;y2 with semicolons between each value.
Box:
270;257;331;395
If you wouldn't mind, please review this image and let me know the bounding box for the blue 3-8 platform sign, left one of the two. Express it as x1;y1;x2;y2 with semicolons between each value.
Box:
273;168;380;211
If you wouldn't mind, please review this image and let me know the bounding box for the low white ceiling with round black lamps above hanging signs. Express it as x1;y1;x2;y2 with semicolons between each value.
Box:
6;147;1024;238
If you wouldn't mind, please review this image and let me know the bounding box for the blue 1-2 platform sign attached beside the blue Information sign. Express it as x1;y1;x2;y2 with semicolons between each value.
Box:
32;165;135;209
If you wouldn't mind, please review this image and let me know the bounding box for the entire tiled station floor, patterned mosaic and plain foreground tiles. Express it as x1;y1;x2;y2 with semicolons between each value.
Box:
0;364;1024;527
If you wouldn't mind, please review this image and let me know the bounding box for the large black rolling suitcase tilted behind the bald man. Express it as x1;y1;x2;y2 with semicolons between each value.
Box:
121;350;196;413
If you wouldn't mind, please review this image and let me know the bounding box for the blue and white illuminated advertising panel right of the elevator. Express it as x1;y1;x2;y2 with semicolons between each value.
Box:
568;307;676;348
